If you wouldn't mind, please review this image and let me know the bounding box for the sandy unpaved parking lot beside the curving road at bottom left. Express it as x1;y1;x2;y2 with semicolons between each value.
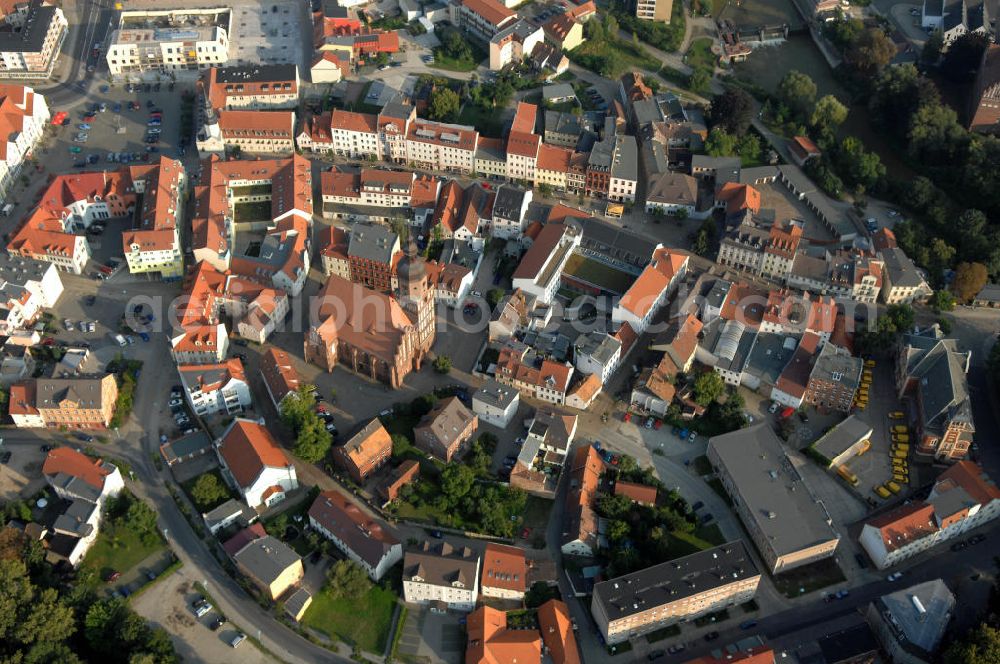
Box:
132;567;272;664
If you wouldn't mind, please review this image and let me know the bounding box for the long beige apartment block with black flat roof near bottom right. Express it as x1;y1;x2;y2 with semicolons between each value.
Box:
590;540;760;644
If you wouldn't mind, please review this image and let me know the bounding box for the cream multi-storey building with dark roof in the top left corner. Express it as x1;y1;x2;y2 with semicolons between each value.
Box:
0;0;69;79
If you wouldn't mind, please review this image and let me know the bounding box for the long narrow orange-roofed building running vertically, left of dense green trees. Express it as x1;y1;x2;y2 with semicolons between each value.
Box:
560;445;604;556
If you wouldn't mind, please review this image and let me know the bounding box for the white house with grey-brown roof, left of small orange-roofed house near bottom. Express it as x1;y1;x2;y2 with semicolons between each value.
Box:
403;542;479;611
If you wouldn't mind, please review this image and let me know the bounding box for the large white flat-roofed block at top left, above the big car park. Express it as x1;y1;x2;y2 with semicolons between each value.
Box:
106;7;232;77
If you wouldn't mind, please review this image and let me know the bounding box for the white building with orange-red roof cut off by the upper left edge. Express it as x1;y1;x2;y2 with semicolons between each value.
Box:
0;83;47;199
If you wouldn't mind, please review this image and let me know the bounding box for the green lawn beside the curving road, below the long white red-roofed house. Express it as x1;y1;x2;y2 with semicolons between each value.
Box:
302;586;396;655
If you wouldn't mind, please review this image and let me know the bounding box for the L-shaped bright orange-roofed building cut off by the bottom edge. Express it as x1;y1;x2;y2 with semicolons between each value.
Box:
465;606;542;664
